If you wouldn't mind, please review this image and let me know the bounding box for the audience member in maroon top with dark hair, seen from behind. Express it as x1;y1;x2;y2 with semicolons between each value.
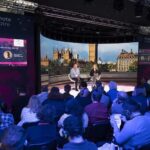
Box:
85;90;108;125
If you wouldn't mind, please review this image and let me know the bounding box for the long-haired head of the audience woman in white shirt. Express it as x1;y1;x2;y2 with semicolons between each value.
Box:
28;95;41;113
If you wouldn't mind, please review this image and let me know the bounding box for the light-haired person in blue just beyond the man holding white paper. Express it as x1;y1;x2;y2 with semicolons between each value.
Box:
111;91;128;114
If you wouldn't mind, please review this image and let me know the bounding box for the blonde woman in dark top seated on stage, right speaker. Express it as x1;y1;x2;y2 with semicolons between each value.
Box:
90;64;101;87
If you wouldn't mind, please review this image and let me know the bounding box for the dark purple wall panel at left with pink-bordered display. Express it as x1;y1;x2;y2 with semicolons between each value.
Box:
0;13;35;106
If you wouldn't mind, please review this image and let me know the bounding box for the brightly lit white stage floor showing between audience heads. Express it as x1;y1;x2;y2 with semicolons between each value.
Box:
57;82;136;97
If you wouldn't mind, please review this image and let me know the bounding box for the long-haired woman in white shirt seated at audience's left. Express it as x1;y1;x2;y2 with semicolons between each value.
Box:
18;95;41;126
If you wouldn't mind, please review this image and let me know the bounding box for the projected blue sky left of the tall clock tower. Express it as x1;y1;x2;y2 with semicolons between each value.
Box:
40;35;89;60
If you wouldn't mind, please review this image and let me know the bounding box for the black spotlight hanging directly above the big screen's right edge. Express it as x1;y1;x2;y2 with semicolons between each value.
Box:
135;0;144;18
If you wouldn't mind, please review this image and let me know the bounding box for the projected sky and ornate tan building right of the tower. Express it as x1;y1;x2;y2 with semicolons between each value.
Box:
98;42;139;72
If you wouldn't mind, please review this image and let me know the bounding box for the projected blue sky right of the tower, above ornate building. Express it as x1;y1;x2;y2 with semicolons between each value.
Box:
98;42;139;62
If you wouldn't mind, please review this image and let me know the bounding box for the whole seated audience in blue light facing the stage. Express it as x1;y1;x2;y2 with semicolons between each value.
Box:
0;81;150;150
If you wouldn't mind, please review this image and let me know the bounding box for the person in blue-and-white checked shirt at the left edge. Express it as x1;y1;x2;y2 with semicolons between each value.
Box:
0;101;14;131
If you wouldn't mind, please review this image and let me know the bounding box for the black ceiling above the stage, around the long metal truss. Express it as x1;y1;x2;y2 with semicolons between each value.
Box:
29;0;150;42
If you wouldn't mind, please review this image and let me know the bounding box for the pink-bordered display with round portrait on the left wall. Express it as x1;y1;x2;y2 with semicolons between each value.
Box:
0;38;27;66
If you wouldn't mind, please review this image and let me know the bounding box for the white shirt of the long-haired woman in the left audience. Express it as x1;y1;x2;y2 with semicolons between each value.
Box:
18;107;39;126
